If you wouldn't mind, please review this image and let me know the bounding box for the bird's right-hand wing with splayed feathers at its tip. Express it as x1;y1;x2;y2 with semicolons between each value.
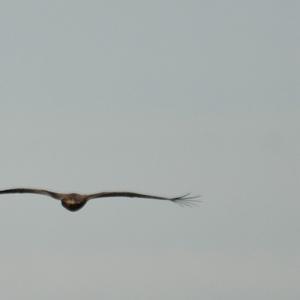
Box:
87;192;200;206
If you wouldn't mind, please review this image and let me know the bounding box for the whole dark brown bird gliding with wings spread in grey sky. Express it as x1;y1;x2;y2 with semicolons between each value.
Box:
0;188;200;211
